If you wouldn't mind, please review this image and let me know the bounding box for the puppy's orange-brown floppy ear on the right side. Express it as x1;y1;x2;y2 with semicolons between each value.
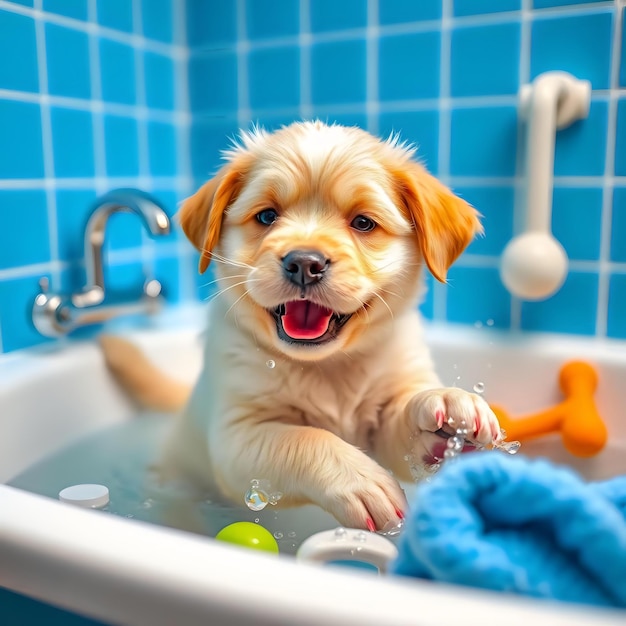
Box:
395;162;482;283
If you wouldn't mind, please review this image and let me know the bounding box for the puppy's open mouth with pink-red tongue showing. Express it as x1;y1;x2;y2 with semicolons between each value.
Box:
270;300;352;344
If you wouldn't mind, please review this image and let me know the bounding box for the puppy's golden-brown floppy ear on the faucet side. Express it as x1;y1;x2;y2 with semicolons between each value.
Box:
178;163;246;274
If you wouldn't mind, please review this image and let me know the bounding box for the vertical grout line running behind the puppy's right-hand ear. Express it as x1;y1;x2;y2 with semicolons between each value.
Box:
433;0;453;320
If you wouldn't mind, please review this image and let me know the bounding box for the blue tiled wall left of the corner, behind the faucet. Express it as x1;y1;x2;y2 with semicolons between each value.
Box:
0;0;190;352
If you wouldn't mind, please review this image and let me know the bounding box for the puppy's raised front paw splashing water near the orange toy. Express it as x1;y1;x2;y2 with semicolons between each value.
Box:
407;387;502;464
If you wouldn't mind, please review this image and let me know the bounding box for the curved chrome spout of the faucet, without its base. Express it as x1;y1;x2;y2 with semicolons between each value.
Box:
71;189;170;308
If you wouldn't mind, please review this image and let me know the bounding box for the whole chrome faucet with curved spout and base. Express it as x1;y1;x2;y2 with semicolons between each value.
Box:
33;189;170;337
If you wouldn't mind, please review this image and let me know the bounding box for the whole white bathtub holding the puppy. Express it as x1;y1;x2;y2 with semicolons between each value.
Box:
0;309;626;626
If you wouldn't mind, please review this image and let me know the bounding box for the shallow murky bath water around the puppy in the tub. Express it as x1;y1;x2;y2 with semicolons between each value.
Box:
8;413;339;554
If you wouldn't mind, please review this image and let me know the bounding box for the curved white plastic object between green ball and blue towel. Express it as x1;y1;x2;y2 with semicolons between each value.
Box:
296;527;398;574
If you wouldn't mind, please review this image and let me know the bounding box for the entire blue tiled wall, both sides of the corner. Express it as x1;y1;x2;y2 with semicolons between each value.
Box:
0;0;626;351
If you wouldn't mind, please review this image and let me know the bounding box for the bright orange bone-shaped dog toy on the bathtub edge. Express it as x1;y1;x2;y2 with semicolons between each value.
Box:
491;361;608;457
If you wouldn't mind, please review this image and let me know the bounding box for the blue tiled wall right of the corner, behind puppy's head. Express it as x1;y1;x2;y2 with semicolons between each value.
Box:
180;0;626;336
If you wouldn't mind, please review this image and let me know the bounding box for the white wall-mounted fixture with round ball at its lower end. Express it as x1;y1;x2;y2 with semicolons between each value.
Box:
500;72;591;300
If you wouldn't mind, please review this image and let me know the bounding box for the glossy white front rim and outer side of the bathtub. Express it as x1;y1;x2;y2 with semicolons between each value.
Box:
0;485;624;626
